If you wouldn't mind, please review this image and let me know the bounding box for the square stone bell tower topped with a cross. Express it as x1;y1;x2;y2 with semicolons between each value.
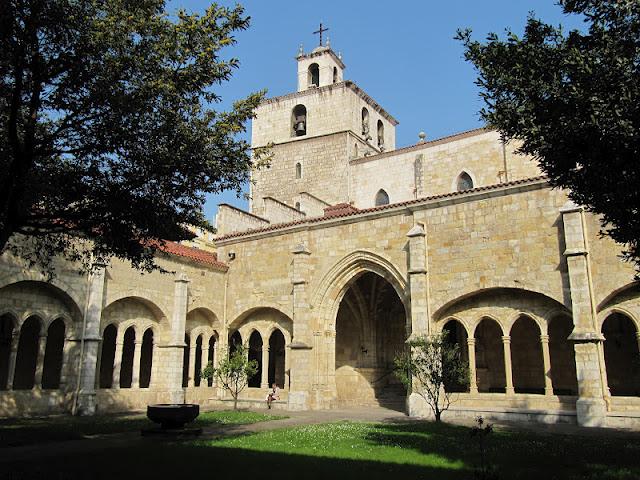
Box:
250;31;398;224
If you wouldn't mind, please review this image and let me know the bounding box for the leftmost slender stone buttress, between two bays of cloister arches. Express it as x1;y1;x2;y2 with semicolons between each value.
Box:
70;261;106;415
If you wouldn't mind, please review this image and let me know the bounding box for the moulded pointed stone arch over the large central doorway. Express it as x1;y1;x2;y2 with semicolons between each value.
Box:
312;250;410;331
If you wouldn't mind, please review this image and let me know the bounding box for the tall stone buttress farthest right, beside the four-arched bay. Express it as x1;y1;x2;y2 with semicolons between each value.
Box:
560;201;608;427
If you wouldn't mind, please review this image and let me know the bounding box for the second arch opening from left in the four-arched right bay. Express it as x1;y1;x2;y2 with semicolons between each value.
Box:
473;316;506;393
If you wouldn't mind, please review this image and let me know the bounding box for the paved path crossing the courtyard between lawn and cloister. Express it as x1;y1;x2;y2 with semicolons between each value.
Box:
0;407;640;464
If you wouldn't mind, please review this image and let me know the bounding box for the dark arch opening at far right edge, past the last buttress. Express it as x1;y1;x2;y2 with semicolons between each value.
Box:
601;311;640;396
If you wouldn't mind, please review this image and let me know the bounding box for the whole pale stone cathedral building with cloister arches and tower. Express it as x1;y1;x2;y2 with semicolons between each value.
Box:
0;46;640;426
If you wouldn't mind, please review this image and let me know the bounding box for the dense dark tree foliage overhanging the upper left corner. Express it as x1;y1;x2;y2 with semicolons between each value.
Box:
0;0;263;269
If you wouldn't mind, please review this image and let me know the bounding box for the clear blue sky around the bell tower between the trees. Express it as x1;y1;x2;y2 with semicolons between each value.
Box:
168;0;581;219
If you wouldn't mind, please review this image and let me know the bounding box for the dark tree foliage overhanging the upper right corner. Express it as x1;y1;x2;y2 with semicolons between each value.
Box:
458;0;640;266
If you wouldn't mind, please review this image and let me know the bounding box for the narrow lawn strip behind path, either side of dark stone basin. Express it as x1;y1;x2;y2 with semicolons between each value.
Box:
0;410;286;448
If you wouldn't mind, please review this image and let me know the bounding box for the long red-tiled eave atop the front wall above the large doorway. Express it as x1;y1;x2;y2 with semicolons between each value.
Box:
214;175;547;241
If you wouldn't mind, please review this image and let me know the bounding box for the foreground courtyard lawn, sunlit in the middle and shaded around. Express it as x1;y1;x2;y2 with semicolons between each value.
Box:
0;413;640;480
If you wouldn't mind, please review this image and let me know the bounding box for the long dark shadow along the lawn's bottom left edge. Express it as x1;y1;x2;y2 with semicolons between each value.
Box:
0;443;471;480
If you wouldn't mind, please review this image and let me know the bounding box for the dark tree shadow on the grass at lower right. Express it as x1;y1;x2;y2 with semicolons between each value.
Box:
367;422;640;480
